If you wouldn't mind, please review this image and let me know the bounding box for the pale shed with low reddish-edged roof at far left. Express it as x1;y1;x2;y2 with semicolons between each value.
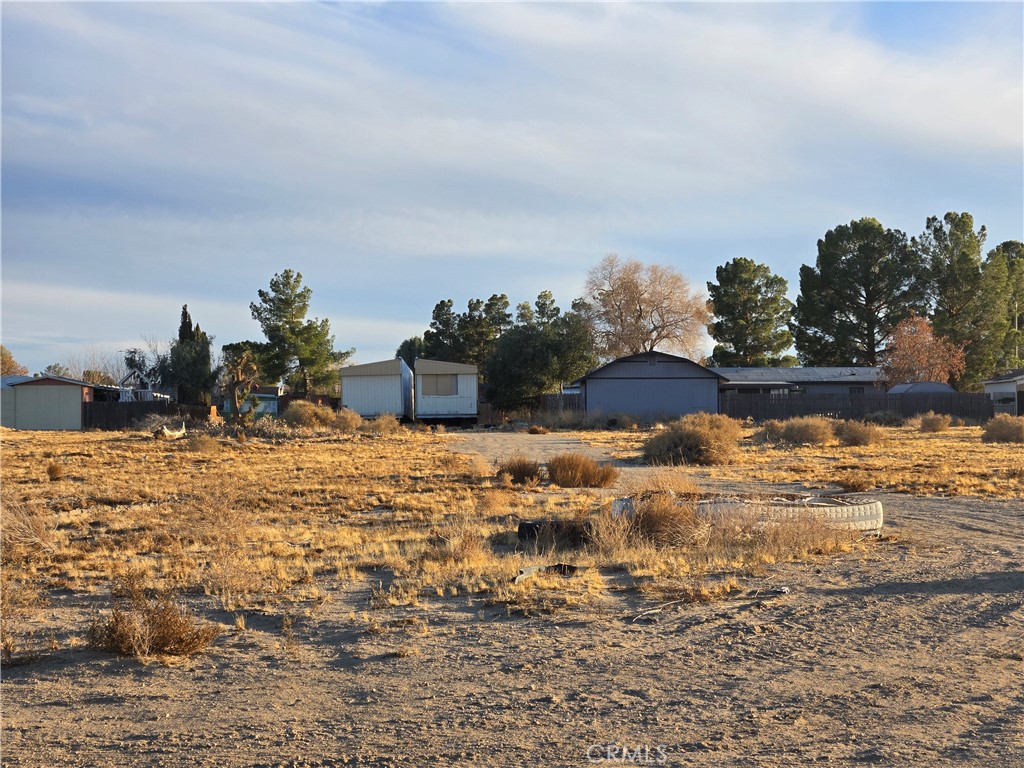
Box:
0;376;96;430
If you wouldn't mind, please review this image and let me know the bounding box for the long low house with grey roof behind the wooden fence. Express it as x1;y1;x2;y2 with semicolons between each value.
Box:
710;366;886;394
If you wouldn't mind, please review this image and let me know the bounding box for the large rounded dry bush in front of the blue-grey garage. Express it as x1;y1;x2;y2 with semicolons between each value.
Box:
643;413;741;465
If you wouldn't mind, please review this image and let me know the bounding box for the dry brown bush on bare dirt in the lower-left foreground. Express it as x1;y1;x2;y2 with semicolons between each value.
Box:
88;589;221;657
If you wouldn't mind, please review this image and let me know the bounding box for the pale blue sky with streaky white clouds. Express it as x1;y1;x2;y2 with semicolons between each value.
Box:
0;0;1024;373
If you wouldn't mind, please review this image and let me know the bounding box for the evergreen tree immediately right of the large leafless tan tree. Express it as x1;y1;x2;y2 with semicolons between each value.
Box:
708;258;796;366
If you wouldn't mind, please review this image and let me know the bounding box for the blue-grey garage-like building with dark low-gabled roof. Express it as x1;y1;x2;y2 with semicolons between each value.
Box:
580;352;723;422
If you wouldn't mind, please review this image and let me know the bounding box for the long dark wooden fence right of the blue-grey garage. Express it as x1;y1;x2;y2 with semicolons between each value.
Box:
719;392;992;422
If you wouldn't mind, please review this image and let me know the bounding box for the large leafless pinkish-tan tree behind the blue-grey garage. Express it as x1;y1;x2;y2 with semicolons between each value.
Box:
585;254;710;357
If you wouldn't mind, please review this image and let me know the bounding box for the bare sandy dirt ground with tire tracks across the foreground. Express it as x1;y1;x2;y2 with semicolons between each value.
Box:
2;434;1024;767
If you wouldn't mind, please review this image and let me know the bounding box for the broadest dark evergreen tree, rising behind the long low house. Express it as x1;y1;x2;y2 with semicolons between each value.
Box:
791;218;928;366
